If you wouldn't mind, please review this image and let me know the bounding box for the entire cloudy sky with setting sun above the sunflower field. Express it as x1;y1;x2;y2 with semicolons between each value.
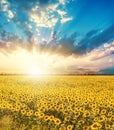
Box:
0;0;114;74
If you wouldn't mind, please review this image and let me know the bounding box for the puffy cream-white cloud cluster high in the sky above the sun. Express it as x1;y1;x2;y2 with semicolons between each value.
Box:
29;1;73;28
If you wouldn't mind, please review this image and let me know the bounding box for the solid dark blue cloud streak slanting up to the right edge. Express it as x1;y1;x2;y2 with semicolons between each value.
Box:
75;24;114;54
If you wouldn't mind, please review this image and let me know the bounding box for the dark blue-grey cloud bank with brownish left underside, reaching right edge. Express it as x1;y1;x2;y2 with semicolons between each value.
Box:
43;25;114;55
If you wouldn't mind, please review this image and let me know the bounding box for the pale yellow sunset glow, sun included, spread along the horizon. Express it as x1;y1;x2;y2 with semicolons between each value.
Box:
0;48;108;75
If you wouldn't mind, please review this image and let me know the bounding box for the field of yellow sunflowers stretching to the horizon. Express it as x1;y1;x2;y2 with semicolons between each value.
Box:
0;76;114;130
